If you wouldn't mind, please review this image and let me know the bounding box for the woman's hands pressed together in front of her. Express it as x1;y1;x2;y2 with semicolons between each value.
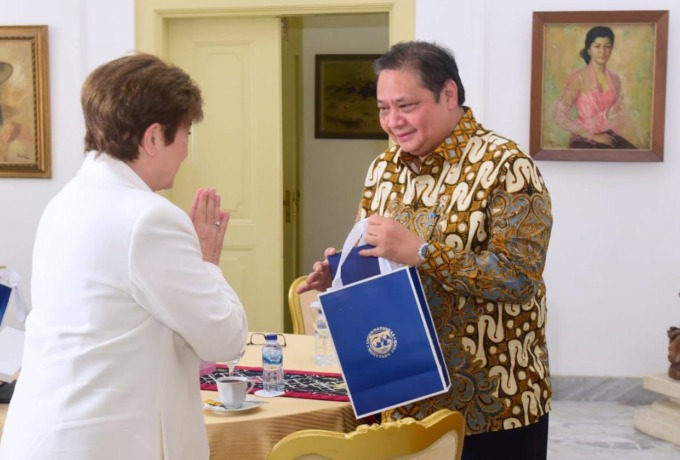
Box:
189;188;229;265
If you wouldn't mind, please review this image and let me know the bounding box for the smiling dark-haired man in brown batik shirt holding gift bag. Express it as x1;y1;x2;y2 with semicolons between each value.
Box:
302;42;552;460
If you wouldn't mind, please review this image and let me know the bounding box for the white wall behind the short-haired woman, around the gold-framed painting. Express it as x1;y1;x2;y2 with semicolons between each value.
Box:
0;0;134;328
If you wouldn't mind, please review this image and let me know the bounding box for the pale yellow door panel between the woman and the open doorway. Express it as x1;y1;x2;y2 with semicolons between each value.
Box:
167;17;284;332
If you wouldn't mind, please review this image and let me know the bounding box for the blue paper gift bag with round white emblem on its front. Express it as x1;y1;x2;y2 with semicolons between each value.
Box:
319;267;451;418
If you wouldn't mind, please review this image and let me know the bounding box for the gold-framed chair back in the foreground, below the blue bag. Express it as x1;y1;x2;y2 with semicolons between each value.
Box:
267;409;465;460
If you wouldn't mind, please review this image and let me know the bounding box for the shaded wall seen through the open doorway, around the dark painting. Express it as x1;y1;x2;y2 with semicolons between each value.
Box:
302;14;389;273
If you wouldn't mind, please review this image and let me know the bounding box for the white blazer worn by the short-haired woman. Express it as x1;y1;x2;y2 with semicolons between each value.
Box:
0;153;248;460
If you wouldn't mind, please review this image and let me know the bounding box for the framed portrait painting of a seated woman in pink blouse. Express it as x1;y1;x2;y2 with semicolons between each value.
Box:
529;11;668;161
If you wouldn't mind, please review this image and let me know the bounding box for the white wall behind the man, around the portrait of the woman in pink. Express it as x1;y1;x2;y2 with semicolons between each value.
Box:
416;0;680;376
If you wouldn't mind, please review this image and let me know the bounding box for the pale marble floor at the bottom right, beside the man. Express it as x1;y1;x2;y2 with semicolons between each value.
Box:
548;400;680;460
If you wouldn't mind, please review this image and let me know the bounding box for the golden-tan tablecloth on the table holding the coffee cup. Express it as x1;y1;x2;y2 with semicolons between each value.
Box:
0;334;359;460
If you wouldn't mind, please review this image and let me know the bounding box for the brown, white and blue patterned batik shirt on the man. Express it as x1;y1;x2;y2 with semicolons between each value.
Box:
358;108;552;434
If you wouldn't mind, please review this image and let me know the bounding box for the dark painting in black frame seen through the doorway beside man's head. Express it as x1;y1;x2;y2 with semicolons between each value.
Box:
314;54;387;139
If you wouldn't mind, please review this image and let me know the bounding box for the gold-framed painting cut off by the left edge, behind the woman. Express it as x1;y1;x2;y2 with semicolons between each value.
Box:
0;26;52;178
